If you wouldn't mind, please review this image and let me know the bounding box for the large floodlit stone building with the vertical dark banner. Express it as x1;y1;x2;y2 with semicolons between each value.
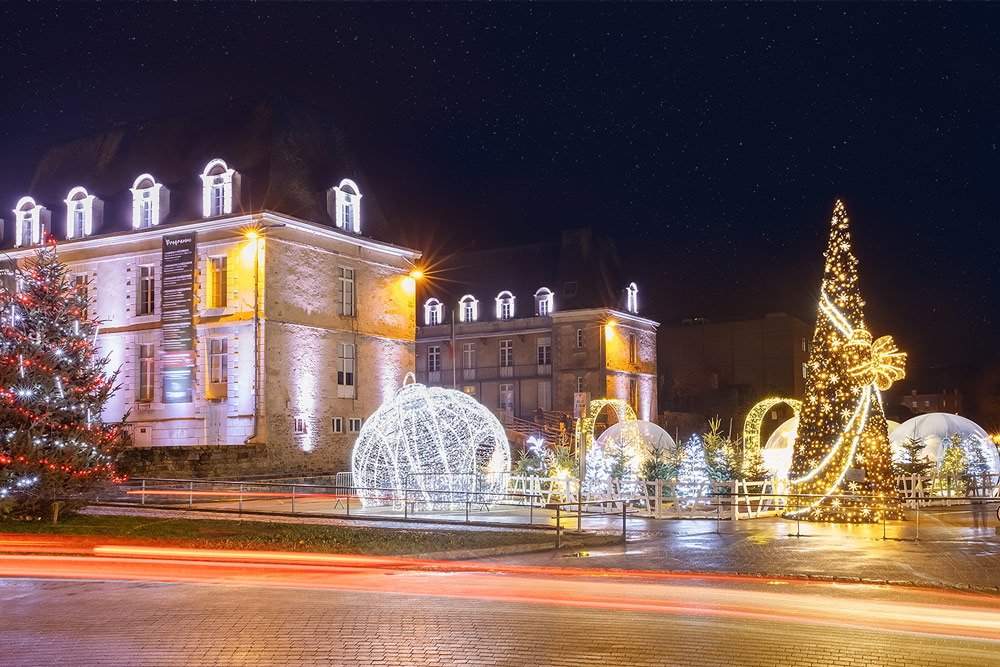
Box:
4;97;420;476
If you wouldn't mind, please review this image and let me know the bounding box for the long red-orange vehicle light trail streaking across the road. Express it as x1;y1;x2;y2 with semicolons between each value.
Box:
0;546;1000;641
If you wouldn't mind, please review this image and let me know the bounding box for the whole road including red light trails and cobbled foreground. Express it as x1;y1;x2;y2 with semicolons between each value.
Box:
0;552;1000;667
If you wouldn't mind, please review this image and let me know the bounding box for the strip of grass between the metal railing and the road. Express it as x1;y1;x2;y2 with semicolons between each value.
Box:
0;514;554;556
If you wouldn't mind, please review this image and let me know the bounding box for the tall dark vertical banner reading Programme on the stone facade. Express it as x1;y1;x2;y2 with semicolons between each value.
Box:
160;232;198;403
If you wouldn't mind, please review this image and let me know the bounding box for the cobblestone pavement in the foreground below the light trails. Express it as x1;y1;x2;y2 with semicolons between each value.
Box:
0;579;1000;667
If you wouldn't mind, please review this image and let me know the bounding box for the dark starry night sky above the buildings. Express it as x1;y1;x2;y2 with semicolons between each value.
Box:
0;3;1000;414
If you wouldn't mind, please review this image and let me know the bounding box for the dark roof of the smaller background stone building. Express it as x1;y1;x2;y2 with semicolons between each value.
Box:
417;228;632;322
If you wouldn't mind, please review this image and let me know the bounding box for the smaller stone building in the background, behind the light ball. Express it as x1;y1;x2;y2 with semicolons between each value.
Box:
416;229;658;423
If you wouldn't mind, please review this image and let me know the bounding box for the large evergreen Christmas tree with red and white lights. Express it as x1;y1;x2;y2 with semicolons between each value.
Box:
0;240;129;515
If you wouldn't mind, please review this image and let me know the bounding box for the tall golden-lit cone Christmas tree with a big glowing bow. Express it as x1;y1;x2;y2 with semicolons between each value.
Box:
789;201;906;522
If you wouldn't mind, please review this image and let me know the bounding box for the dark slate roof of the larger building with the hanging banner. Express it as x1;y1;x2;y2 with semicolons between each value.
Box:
3;95;391;245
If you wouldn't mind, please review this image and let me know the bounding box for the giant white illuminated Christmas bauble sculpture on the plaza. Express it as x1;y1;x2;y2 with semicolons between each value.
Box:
351;373;511;509
